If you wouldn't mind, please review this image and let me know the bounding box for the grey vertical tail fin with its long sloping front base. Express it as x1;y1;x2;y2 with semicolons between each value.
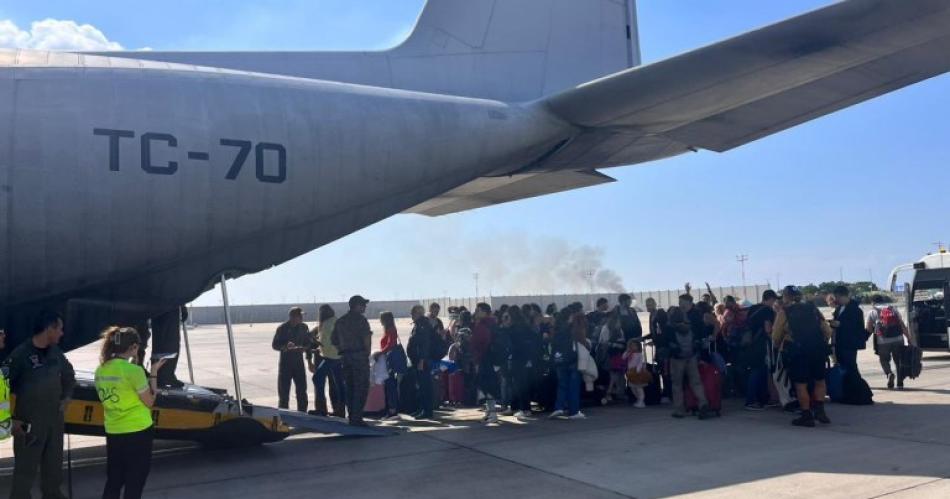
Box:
102;0;640;102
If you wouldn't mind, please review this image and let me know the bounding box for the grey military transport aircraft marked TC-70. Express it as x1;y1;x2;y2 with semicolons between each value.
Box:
0;0;950;446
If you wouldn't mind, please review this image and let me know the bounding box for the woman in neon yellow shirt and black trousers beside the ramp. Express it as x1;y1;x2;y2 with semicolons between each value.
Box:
96;326;165;499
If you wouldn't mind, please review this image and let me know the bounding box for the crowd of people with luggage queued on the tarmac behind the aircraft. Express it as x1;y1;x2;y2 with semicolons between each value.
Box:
273;284;914;426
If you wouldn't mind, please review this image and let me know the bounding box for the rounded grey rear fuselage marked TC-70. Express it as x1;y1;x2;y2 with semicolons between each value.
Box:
0;52;570;348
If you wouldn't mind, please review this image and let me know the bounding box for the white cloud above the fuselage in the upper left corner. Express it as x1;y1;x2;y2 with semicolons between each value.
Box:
0;19;124;51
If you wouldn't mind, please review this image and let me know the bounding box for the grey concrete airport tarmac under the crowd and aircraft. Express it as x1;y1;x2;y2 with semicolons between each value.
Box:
0;321;950;499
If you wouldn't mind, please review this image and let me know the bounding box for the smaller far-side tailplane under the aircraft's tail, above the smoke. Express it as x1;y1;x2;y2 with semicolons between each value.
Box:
405;170;615;217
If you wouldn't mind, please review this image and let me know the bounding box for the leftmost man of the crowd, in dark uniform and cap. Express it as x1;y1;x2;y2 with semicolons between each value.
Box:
271;307;314;412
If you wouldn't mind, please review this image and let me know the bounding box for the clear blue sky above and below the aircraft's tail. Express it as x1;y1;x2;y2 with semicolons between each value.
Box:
0;0;950;303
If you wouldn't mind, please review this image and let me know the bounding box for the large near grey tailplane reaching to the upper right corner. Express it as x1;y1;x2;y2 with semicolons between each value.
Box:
539;0;950;154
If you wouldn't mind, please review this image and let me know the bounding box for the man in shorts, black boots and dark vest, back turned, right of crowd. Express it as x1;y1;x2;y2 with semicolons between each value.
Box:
772;286;832;427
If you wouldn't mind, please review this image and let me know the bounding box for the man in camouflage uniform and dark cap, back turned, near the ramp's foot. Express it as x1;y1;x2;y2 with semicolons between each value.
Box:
332;295;373;426
